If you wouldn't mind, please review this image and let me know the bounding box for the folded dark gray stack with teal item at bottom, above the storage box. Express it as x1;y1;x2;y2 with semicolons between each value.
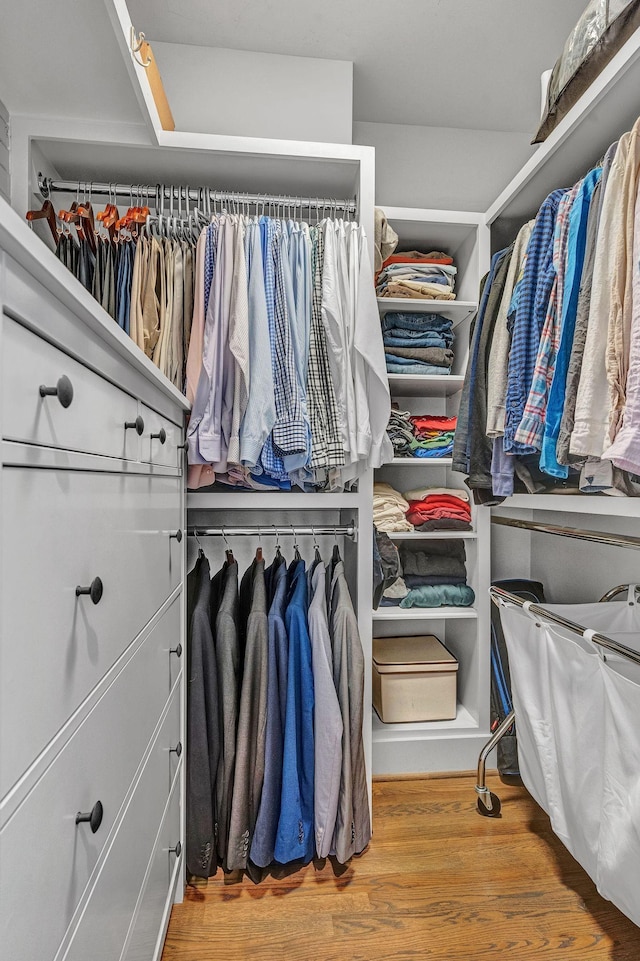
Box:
381;540;475;608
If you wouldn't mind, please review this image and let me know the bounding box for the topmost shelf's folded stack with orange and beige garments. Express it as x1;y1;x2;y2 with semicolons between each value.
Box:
376;250;457;300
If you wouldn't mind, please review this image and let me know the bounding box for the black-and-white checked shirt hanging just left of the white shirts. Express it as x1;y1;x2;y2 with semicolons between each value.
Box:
307;221;344;470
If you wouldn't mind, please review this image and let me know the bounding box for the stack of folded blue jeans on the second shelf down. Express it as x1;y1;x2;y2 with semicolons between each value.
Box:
382;310;454;374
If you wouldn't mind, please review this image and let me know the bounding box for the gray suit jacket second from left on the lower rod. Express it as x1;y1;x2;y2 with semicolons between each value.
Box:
216;561;240;870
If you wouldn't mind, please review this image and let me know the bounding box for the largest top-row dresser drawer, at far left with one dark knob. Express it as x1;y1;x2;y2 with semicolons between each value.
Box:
2;314;140;460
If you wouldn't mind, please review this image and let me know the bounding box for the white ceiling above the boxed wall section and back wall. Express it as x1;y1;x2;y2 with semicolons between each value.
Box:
128;0;586;134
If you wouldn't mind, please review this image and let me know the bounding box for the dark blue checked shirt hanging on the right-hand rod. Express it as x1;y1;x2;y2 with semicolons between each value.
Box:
504;189;567;454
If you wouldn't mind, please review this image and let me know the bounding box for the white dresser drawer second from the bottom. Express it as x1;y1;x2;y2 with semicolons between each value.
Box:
61;704;180;961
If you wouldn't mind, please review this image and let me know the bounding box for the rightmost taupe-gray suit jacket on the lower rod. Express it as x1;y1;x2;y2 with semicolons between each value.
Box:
329;561;371;864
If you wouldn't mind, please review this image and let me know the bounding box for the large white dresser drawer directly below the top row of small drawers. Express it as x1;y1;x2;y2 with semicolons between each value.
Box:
0;468;182;797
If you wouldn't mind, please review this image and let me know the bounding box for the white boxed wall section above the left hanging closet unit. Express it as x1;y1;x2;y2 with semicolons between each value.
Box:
152;41;353;143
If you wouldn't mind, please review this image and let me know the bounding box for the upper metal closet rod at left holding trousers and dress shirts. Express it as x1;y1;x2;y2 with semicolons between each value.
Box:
38;173;358;214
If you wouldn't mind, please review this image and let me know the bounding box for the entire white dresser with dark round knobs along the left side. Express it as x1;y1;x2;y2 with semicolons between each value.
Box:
0;200;188;961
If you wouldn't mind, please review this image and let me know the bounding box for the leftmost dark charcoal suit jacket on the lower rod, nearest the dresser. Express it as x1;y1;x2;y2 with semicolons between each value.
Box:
186;557;220;878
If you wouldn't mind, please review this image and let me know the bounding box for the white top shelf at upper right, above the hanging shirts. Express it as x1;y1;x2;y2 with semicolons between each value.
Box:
486;31;640;235
